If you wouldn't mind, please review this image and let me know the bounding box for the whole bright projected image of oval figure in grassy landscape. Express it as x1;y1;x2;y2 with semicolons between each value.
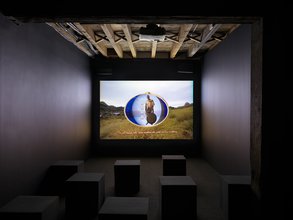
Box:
100;81;193;139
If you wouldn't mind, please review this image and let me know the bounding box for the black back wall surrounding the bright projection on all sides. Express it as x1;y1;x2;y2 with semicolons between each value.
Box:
92;58;200;156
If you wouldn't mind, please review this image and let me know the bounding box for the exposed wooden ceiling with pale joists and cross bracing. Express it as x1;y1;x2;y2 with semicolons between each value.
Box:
47;22;239;59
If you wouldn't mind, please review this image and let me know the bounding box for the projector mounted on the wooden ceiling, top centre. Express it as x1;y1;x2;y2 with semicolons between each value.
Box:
139;24;166;41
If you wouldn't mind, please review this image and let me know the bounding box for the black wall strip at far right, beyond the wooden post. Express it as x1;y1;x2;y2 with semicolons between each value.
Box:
260;14;293;219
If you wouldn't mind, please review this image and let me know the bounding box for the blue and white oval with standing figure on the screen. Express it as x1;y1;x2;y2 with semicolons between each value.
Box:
124;94;169;127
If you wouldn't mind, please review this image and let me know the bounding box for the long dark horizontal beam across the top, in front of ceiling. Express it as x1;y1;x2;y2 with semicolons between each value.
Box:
12;15;260;24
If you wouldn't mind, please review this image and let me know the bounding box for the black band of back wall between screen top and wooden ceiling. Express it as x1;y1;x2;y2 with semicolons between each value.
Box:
92;57;200;80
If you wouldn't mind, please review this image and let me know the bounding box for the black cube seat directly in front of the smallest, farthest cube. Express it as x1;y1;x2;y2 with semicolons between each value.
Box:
159;176;197;220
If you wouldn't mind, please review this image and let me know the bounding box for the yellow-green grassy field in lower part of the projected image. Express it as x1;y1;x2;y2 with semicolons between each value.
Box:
100;106;193;139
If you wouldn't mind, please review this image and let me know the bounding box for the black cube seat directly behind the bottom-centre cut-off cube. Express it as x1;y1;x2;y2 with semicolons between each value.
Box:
114;160;140;196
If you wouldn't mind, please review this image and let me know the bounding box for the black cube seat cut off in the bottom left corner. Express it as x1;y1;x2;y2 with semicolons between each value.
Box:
0;196;59;220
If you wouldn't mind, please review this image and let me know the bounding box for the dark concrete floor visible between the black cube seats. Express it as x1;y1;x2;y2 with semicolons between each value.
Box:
78;157;224;220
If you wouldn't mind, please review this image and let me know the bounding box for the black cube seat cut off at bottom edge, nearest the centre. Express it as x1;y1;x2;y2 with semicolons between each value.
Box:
99;197;149;220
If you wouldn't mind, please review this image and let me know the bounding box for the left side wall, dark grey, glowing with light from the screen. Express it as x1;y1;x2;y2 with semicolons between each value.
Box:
0;14;91;206
